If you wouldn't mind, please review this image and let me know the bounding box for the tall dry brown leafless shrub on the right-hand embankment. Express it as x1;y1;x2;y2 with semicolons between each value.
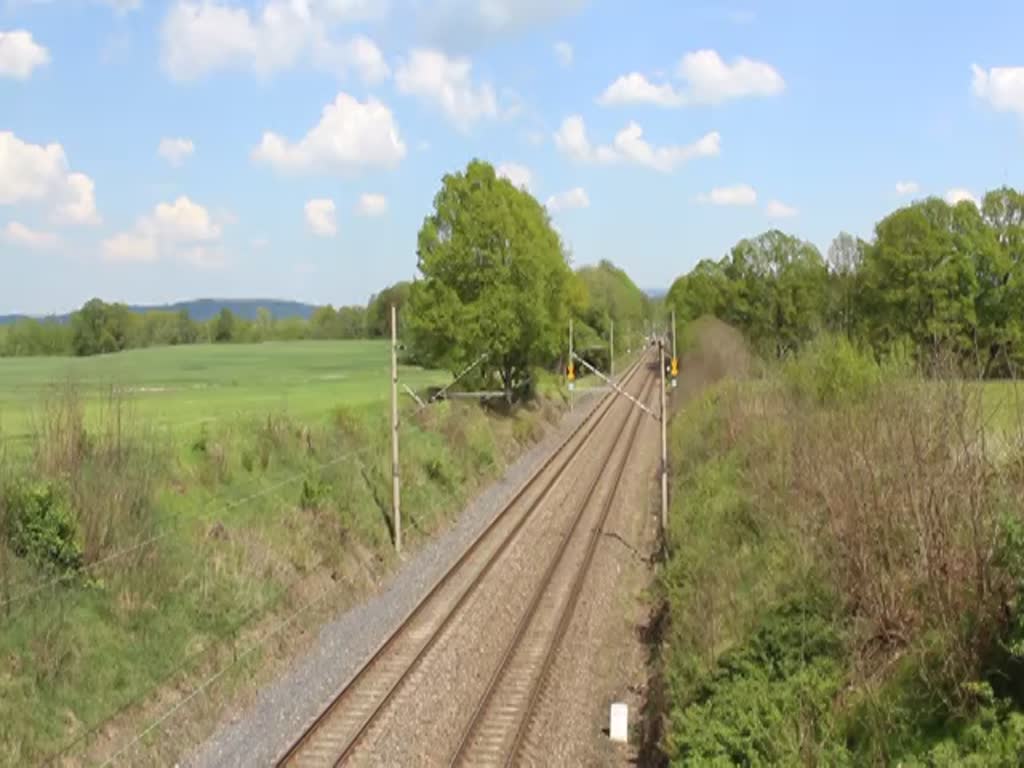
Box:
790;380;1005;690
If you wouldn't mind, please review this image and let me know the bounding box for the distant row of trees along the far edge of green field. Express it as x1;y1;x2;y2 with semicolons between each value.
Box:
0;282;411;357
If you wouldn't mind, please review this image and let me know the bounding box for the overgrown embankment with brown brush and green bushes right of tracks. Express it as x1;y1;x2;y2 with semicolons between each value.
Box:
660;325;1024;766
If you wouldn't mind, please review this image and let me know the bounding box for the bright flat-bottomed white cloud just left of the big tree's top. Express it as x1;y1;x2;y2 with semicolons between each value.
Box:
252;93;406;173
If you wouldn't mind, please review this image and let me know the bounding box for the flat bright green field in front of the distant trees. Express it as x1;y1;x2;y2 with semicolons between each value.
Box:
0;341;450;438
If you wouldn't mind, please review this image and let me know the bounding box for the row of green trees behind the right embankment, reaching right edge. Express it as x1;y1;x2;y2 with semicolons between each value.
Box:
667;187;1024;376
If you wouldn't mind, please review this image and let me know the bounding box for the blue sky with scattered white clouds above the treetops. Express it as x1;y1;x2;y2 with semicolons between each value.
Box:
0;0;1024;313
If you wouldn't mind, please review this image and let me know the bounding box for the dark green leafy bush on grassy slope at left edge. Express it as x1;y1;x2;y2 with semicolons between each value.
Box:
2;482;82;572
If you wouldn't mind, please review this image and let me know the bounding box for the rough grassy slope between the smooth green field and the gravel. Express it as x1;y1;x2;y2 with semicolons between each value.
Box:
0;374;560;764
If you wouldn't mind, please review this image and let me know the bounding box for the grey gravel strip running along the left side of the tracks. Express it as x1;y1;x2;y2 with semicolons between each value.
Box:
181;390;600;768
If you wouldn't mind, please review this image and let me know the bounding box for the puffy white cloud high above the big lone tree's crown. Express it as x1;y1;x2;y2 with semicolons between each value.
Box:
394;49;498;130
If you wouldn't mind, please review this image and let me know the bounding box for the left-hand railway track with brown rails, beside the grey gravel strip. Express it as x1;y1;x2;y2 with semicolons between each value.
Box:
276;358;644;766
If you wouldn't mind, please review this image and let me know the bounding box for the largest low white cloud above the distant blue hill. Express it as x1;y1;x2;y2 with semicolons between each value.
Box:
101;195;224;266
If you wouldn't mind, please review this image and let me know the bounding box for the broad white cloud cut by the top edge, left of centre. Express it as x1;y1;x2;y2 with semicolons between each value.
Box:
161;0;390;83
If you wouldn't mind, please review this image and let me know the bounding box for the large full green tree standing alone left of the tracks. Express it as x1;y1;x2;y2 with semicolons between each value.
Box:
407;161;572;399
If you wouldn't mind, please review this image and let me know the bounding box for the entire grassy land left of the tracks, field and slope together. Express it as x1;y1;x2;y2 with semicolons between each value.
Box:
0;342;577;765
